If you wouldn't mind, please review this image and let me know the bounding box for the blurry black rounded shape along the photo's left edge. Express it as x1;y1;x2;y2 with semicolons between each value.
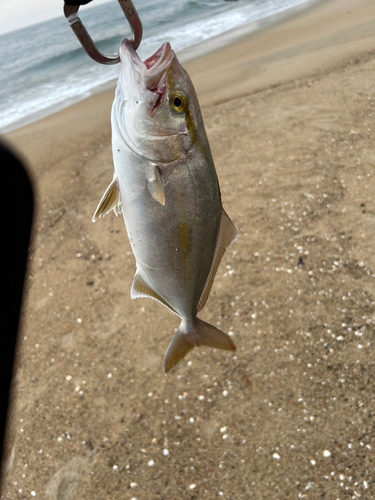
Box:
0;143;34;487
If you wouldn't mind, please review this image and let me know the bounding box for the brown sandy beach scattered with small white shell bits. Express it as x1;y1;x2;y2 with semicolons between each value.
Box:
1;0;375;500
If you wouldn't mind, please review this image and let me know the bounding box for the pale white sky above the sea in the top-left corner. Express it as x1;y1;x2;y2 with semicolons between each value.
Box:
0;0;111;34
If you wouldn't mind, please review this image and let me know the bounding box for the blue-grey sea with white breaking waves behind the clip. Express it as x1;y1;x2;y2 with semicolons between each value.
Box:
0;0;318;133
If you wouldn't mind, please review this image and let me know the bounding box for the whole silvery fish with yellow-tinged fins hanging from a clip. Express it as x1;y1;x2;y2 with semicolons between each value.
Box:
92;39;238;373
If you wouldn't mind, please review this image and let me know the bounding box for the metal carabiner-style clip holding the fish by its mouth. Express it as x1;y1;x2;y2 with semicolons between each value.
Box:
64;0;143;64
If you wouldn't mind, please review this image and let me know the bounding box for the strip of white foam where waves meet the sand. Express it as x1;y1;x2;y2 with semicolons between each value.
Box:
0;0;329;137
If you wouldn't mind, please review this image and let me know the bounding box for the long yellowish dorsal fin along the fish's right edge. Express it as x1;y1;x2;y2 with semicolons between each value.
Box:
197;209;238;311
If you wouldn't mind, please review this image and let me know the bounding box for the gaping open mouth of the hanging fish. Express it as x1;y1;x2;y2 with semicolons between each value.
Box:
120;38;175;89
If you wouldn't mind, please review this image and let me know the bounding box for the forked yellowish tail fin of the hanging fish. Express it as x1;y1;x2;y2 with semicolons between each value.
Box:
164;318;236;373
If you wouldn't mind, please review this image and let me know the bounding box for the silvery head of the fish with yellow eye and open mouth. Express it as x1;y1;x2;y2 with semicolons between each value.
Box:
114;39;204;163
